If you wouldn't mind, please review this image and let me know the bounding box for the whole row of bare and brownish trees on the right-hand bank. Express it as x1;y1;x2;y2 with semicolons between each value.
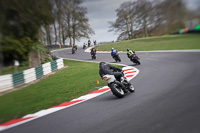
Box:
109;0;199;41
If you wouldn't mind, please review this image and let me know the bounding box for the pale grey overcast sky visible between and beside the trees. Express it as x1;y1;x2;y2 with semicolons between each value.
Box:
78;0;200;46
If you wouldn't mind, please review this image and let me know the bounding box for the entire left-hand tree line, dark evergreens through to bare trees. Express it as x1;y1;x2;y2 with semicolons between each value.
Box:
0;0;94;67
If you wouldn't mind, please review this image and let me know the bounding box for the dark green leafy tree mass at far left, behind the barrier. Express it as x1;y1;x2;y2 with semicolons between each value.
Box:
0;0;52;66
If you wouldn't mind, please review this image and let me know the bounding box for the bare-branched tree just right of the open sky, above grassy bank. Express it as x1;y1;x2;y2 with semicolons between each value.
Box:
109;0;154;40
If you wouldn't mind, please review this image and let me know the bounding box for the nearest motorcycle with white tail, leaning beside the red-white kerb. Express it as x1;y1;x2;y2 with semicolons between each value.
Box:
103;71;135;98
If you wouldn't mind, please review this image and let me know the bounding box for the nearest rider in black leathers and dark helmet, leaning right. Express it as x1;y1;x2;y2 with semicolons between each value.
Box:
99;62;123;81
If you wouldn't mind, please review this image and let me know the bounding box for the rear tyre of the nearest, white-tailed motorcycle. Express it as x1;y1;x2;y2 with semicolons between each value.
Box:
110;83;124;98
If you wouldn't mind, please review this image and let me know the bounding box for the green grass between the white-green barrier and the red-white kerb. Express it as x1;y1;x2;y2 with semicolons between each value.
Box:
0;60;115;123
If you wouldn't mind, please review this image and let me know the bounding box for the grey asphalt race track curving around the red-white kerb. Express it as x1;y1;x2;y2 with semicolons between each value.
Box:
2;49;200;133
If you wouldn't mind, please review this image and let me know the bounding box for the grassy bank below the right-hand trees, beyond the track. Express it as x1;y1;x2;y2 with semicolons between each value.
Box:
96;34;200;51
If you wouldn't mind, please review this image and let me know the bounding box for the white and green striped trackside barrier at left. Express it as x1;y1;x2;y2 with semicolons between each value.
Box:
0;59;64;92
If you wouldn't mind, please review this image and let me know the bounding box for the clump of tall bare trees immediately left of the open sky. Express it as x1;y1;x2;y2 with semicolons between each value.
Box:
42;0;94;46
